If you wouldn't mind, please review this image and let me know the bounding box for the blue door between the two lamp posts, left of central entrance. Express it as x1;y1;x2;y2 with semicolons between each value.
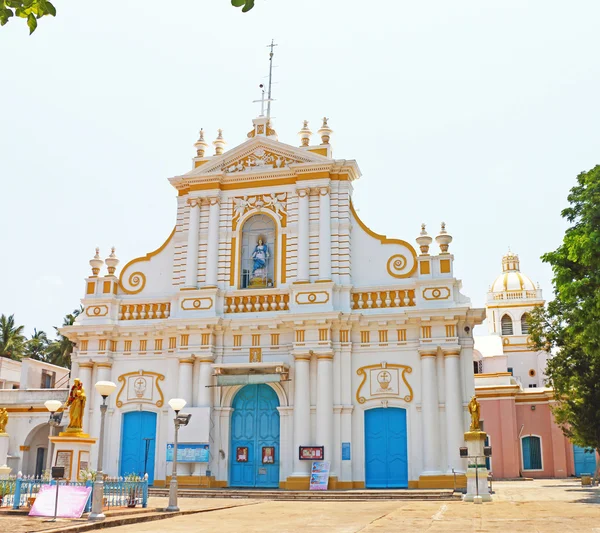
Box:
120;411;156;485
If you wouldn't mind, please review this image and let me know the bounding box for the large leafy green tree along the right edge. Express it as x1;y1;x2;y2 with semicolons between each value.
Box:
529;165;600;478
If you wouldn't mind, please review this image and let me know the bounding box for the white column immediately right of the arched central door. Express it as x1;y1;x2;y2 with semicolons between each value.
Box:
292;354;310;476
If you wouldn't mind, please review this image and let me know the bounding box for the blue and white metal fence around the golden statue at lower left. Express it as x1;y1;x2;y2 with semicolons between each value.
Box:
0;475;148;513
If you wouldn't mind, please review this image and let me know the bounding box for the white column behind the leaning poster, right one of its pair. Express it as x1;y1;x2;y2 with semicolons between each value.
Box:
316;354;335;475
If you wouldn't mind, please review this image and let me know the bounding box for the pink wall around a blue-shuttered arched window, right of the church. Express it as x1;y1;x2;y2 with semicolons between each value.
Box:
479;396;574;478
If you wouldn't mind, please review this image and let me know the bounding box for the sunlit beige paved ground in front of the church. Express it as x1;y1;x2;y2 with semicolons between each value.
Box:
0;480;600;533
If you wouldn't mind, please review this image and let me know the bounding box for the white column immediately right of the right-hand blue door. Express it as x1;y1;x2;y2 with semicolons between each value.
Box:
420;349;440;475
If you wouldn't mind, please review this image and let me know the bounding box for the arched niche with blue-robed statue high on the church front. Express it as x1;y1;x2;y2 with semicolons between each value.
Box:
240;215;276;289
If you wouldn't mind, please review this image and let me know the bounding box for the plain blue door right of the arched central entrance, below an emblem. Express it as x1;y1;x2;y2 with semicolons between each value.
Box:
365;407;408;489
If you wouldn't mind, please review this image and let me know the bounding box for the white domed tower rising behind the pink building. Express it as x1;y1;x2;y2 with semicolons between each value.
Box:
473;252;547;388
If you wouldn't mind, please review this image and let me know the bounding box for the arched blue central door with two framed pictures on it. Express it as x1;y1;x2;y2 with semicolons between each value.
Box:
229;384;279;488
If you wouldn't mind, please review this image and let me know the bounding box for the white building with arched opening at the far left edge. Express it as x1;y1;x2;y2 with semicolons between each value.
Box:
0;357;69;476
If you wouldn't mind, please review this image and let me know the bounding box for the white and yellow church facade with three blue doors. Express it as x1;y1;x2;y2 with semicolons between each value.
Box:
61;116;485;489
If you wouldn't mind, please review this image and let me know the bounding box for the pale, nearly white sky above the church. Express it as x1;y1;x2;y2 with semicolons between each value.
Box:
0;0;600;335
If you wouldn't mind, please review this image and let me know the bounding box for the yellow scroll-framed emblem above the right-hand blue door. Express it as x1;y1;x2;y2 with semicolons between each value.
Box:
356;361;413;404
